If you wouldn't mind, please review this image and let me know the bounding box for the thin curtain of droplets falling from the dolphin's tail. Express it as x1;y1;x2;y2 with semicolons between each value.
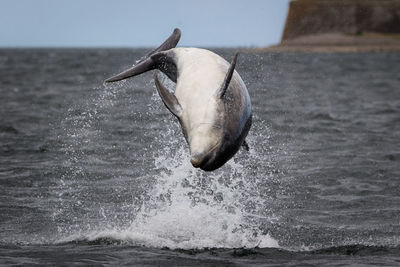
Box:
51;83;122;238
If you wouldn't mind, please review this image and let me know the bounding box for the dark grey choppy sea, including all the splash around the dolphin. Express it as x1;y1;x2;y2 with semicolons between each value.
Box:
0;49;400;266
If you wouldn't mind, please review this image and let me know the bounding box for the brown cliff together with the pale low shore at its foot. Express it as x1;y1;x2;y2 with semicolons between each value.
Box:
261;0;400;52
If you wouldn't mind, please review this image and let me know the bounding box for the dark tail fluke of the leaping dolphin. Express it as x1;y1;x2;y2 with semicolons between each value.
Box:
105;28;181;83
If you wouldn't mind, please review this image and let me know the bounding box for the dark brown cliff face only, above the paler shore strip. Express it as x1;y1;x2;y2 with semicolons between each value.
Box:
282;0;400;41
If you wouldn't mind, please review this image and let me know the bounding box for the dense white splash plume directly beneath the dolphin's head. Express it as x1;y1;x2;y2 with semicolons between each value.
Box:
58;149;278;249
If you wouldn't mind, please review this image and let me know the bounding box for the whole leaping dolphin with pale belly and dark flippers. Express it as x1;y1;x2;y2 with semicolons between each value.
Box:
105;29;252;171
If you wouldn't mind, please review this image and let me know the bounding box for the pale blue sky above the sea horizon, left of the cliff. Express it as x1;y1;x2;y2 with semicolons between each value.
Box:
0;0;289;47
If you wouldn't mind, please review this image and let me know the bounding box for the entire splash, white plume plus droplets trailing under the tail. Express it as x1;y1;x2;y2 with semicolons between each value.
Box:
56;78;278;249
